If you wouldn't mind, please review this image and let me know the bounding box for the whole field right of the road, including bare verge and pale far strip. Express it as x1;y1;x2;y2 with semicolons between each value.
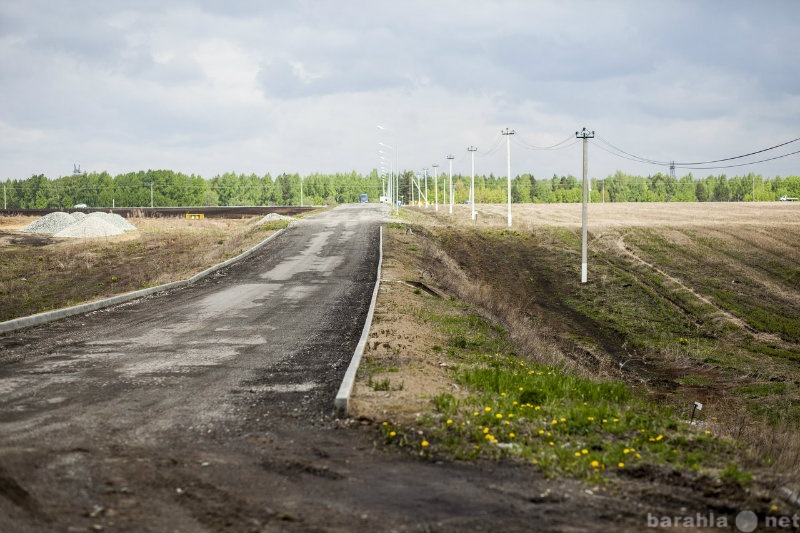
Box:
355;203;800;502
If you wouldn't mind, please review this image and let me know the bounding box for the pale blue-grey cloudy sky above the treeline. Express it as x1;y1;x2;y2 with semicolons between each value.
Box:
0;0;800;179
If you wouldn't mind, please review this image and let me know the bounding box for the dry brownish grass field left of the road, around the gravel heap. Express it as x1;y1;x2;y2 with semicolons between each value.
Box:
0;216;285;320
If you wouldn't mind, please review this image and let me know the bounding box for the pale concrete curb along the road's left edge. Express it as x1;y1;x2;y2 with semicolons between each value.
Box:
0;227;293;334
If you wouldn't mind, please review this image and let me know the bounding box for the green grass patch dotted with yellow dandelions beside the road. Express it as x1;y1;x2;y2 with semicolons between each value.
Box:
381;290;741;481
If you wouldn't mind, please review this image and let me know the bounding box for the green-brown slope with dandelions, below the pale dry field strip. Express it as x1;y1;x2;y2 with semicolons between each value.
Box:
372;206;800;488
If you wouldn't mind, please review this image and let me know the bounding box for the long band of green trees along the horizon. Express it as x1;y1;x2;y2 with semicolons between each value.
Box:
2;170;800;209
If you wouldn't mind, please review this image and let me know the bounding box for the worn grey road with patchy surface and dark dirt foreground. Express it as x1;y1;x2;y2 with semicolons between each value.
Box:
0;206;752;532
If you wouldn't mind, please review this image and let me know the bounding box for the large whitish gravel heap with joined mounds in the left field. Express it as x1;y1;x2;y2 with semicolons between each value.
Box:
21;211;136;238
